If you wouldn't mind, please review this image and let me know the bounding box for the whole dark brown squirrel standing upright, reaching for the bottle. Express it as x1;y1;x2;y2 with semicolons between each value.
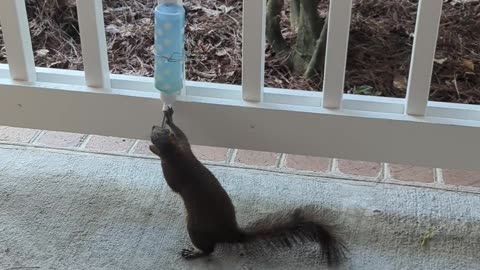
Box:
150;108;346;266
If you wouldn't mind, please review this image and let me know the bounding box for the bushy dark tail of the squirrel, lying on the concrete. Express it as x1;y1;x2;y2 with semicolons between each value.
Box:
238;206;347;265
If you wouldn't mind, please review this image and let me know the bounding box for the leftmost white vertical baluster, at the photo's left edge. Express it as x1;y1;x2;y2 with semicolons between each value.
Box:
0;0;36;81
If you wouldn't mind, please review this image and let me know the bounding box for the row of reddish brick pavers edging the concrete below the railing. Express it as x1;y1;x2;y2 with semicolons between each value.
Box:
0;126;480;192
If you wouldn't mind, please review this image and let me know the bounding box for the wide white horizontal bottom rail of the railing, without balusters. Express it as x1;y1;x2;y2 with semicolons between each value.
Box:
0;65;480;170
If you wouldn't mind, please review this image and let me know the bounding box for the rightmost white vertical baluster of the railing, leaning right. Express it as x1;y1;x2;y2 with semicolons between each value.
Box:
406;0;443;116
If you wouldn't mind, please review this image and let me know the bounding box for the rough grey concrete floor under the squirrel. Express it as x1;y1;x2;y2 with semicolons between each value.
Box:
0;142;480;270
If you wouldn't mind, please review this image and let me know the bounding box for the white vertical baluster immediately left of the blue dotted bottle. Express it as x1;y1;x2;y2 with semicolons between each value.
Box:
77;0;110;88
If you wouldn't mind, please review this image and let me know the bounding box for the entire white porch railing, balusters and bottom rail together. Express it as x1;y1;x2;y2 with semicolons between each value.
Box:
0;0;480;170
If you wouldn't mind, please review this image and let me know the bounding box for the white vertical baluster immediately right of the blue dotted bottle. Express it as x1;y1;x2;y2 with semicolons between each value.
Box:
242;0;266;101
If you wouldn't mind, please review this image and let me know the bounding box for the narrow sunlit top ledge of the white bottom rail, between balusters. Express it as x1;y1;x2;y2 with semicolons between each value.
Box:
0;64;480;121
